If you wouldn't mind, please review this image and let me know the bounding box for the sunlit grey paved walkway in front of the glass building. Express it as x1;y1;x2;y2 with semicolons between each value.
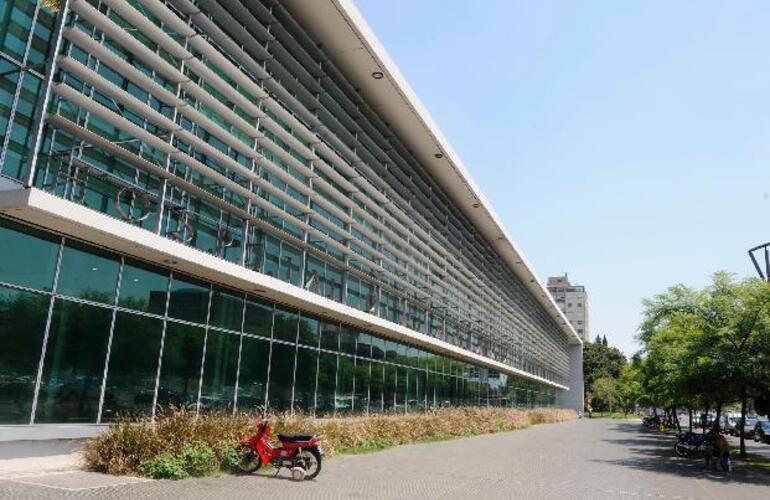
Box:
0;419;770;500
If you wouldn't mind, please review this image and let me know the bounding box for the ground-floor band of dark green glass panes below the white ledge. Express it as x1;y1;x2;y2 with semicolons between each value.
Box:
0;218;555;424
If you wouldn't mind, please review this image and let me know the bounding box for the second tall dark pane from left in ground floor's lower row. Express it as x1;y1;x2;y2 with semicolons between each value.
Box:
35;300;112;423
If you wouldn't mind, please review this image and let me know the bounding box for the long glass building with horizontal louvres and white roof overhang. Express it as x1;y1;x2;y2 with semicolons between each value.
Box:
0;0;582;433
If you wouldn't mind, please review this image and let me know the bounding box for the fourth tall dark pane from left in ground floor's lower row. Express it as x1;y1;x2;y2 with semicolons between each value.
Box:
158;321;204;410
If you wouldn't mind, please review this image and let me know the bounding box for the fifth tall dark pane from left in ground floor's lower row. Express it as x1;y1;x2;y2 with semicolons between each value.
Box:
201;330;240;411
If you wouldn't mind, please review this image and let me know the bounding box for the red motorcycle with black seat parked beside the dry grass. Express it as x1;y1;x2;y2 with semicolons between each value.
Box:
238;418;323;479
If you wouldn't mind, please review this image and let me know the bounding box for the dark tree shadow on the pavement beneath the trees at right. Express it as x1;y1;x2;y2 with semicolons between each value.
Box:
592;423;770;486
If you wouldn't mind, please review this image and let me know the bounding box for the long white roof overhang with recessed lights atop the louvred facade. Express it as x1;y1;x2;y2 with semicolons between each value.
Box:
282;0;582;344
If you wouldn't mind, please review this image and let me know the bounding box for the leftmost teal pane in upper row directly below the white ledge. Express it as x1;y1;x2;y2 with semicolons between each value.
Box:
0;219;60;292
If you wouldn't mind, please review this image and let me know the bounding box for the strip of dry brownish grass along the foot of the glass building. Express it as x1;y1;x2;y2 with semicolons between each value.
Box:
84;408;577;475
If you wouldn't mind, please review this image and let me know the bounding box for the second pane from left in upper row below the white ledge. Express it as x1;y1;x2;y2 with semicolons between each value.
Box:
56;241;120;304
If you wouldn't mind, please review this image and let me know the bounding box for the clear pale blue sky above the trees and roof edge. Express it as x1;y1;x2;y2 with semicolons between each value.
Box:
356;0;770;355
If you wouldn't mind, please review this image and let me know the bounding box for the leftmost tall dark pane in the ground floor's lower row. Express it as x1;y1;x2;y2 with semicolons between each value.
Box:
0;287;51;424
